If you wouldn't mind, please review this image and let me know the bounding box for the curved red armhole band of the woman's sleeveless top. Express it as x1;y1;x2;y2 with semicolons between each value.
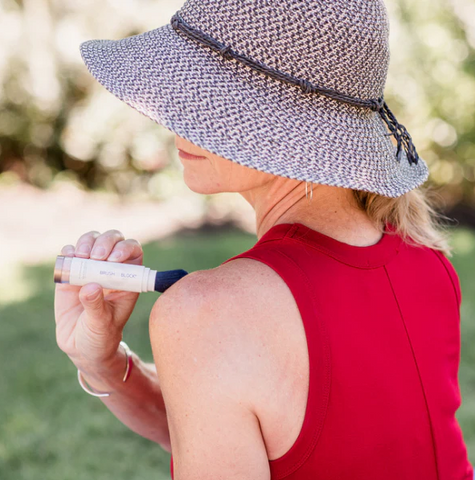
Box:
223;244;331;480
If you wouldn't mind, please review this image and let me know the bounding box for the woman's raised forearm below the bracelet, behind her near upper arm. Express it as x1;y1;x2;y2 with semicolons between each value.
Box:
83;348;171;453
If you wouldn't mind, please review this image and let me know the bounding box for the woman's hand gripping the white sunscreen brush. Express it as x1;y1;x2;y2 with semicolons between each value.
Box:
54;230;143;378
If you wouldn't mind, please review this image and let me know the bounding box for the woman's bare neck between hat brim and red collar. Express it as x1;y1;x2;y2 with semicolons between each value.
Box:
240;177;381;246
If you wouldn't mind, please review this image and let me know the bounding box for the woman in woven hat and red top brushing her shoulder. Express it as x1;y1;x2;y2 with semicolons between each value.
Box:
55;0;473;480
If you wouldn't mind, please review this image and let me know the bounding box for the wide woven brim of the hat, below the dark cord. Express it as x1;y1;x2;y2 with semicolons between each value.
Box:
80;24;429;197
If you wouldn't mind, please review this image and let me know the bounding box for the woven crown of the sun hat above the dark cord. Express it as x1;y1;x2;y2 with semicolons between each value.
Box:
179;0;389;99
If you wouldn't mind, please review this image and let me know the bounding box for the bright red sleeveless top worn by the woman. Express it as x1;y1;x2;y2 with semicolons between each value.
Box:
170;223;473;480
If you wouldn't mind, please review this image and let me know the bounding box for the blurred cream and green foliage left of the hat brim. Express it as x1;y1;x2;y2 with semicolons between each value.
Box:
0;0;191;199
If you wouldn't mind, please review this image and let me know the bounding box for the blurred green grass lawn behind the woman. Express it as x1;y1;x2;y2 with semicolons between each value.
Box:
0;229;475;480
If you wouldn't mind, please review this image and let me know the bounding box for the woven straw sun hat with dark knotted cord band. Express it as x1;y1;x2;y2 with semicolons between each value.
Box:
80;0;429;197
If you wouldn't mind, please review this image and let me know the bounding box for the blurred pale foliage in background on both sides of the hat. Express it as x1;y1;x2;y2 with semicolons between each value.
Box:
0;0;475;224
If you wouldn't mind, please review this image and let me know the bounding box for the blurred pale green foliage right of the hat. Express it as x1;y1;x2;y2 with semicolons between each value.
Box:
388;0;475;224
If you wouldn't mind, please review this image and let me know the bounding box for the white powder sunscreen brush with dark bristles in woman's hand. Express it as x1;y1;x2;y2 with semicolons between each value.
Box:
54;255;188;293
